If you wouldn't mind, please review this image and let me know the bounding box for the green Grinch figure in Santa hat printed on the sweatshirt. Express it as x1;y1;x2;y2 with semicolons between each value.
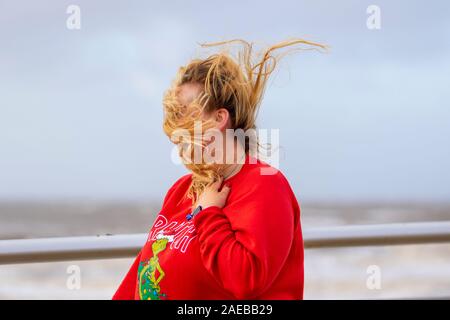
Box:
138;232;174;300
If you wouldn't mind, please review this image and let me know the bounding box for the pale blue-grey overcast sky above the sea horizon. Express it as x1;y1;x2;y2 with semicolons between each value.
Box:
0;0;450;202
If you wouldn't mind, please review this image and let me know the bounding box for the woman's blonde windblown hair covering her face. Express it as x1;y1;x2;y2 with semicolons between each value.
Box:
163;39;326;201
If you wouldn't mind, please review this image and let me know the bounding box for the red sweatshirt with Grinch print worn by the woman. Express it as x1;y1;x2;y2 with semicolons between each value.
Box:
113;157;303;300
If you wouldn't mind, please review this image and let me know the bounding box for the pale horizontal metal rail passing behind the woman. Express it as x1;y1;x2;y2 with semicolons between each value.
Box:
0;221;450;265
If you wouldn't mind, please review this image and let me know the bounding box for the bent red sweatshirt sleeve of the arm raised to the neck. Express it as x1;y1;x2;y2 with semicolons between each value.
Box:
193;173;294;299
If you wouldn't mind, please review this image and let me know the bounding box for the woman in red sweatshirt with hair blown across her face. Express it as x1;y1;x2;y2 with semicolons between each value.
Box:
113;40;323;300
